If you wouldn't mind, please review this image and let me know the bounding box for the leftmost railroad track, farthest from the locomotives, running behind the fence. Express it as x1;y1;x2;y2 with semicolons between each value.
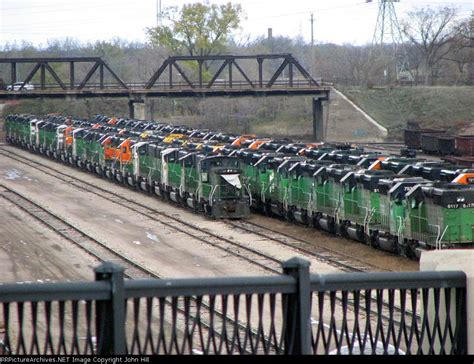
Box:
0;183;268;353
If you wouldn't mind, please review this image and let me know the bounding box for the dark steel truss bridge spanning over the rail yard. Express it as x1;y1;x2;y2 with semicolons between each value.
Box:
0;54;329;140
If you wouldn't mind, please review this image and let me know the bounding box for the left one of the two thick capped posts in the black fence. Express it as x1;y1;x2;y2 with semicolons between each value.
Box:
94;262;126;355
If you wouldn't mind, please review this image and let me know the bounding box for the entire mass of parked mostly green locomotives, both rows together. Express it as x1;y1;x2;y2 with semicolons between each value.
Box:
6;115;474;258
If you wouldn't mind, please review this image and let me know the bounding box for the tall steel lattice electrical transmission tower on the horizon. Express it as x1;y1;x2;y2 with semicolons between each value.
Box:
366;0;412;80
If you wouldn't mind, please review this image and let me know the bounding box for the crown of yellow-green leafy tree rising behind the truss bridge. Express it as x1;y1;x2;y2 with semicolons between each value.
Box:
146;2;242;62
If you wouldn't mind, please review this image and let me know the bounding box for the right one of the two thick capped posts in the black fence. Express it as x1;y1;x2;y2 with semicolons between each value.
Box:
282;258;311;355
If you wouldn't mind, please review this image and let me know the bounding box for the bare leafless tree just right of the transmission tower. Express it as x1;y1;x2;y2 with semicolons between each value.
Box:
402;7;457;85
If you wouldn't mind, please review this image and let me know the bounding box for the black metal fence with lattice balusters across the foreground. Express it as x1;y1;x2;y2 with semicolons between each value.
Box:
0;258;467;354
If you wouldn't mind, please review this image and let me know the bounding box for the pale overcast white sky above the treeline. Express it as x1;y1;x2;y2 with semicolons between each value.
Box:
0;0;474;47
